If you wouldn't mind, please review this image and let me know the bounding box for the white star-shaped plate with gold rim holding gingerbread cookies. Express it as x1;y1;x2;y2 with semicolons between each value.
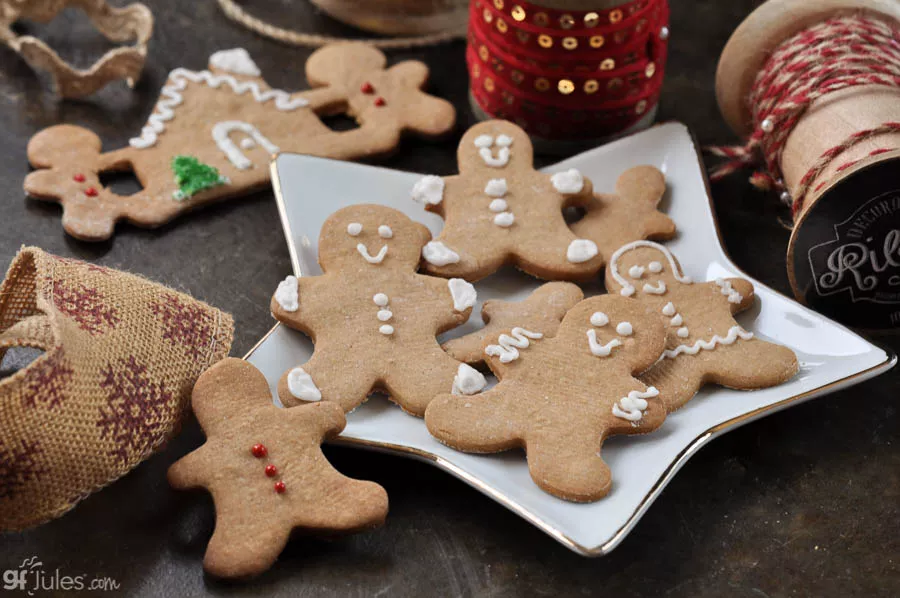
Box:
247;123;895;556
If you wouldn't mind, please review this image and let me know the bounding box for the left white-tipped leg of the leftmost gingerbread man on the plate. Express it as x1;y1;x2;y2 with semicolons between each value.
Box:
278;351;375;413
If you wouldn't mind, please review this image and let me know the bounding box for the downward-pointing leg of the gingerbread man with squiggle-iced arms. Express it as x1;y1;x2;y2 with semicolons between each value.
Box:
525;426;612;502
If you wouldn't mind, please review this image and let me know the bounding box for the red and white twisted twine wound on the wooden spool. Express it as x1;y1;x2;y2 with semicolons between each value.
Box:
708;15;900;216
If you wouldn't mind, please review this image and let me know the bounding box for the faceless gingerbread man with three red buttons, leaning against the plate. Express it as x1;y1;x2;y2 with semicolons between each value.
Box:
168;358;388;577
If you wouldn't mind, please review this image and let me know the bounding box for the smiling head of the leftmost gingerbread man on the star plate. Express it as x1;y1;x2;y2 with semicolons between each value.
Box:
319;204;431;271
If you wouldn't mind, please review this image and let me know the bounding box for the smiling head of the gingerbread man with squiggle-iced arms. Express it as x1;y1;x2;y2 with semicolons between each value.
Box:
557;295;666;374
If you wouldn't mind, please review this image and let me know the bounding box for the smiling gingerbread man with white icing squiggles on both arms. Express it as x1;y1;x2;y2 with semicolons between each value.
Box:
425;295;666;502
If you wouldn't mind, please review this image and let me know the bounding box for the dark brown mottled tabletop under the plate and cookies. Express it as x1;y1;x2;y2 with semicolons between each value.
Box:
0;0;900;598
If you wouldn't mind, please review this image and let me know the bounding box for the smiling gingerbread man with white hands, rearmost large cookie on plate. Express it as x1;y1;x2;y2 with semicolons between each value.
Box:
412;120;603;281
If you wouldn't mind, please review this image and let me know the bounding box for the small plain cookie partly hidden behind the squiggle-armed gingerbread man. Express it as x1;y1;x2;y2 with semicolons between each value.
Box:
441;282;584;365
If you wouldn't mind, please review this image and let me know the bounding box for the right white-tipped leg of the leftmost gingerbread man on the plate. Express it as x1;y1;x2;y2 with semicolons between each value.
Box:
384;352;485;417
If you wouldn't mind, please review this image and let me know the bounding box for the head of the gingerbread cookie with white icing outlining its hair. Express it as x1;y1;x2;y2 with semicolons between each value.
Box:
606;241;691;298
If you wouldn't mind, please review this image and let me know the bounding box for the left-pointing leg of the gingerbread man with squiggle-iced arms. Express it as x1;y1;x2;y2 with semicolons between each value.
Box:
425;390;524;453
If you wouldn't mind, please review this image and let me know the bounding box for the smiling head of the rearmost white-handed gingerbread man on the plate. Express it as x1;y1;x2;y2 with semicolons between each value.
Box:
457;120;534;174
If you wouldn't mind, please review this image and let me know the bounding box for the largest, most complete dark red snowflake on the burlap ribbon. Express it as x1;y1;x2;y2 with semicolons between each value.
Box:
97;356;176;464
